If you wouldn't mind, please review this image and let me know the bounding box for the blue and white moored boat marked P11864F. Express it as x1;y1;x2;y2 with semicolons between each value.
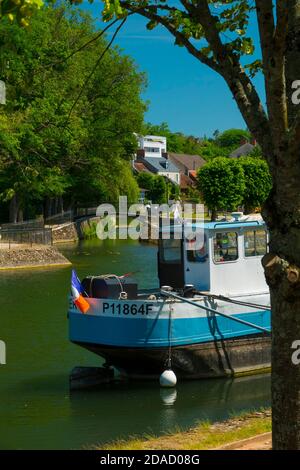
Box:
68;217;271;379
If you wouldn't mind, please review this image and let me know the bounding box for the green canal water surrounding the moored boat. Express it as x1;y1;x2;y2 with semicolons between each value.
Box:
0;240;270;449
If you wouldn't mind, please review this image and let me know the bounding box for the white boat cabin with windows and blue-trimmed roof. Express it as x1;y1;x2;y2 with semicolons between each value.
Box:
158;220;268;296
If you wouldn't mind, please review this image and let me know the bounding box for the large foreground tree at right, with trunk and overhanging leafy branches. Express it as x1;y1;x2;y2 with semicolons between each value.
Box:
81;0;300;449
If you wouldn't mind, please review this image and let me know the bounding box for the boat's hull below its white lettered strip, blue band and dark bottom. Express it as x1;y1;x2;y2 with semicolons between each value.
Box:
69;301;271;379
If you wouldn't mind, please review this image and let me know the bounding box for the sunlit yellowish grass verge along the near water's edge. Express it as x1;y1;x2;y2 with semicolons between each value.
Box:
94;409;271;450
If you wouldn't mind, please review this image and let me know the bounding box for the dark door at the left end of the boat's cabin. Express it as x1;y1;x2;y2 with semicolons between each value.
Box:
158;237;185;289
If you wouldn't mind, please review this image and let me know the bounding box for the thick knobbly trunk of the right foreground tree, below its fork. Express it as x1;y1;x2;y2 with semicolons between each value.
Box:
262;163;300;450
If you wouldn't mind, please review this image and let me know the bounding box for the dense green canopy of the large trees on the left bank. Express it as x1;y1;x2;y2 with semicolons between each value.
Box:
0;6;145;218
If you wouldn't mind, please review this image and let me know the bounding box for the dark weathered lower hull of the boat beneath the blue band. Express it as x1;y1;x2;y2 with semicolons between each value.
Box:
76;335;271;379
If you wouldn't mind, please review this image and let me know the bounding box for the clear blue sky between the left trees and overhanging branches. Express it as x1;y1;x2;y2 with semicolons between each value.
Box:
78;0;264;136
